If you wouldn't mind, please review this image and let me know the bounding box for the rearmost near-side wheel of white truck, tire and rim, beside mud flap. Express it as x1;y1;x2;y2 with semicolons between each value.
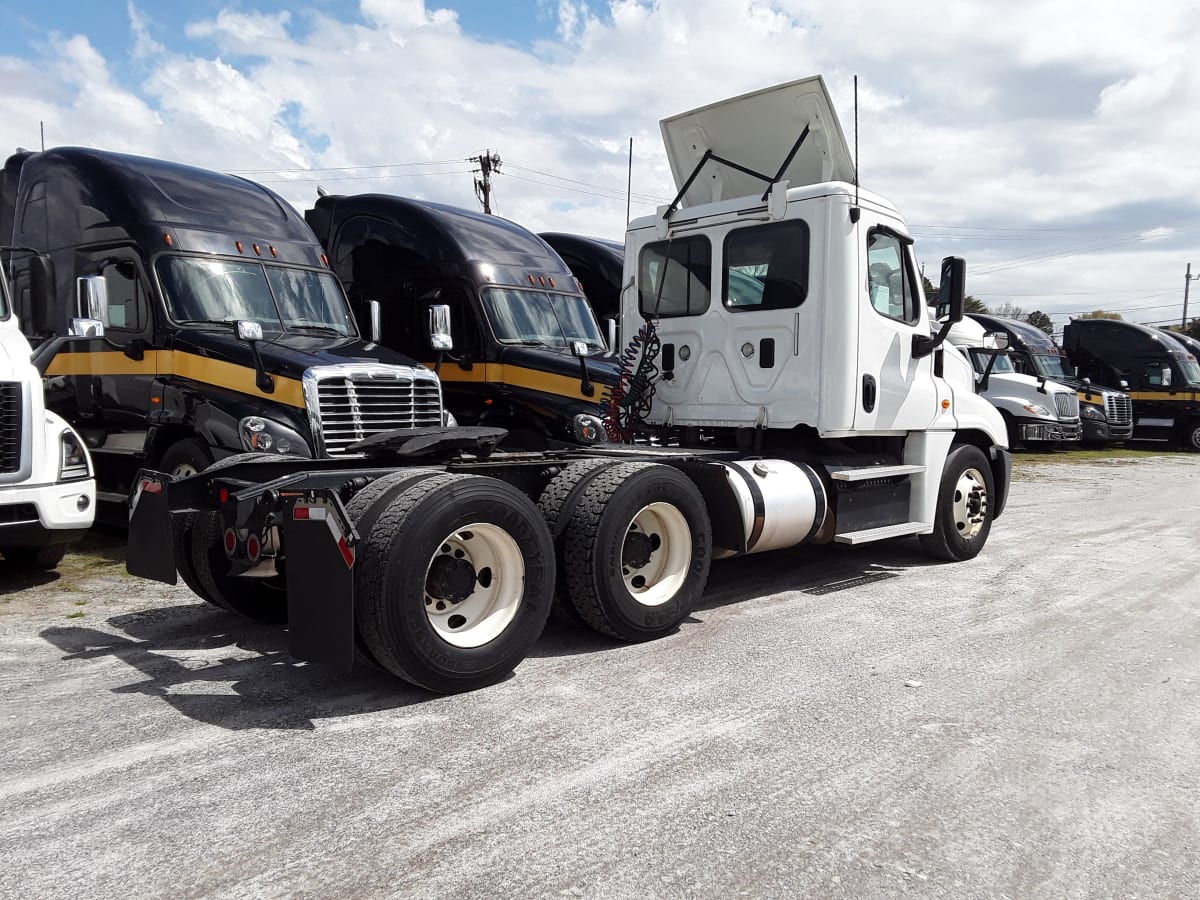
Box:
354;474;554;694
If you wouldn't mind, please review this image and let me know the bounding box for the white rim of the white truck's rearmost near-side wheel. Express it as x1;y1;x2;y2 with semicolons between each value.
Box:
425;522;524;648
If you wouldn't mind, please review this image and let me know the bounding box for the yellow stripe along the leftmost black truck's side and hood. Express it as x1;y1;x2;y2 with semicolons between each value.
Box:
46;350;304;409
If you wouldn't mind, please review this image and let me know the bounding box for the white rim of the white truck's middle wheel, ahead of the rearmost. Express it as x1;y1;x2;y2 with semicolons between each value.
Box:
620;503;691;606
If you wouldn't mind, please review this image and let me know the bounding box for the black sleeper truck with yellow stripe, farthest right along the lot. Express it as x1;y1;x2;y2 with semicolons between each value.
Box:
1062;319;1200;451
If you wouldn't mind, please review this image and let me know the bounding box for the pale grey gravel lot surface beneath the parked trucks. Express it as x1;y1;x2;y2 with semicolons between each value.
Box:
0;456;1200;898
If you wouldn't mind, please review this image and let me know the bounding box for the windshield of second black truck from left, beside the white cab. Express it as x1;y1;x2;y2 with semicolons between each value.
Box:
482;288;604;350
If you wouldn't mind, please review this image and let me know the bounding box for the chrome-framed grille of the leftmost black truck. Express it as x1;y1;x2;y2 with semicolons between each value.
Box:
305;366;442;456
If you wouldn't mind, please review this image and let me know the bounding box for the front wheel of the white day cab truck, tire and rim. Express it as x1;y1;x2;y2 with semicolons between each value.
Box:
920;444;996;563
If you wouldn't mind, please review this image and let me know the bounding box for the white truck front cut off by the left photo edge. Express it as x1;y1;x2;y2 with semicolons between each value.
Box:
0;247;96;569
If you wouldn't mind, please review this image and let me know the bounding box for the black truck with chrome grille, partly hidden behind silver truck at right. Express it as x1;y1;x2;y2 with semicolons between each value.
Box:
968;313;1133;446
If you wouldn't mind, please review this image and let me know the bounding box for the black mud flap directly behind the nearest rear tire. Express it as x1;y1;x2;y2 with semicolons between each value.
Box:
283;500;354;672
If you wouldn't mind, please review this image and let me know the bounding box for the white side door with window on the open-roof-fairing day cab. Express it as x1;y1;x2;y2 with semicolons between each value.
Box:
854;229;938;431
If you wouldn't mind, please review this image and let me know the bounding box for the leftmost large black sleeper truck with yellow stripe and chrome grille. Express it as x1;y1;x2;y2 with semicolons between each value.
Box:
0;148;444;502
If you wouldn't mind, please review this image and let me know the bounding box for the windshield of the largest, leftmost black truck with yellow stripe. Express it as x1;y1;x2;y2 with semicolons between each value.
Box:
155;256;358;337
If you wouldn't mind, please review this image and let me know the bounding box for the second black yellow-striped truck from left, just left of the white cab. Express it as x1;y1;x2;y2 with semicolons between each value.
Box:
305;194;619;449
